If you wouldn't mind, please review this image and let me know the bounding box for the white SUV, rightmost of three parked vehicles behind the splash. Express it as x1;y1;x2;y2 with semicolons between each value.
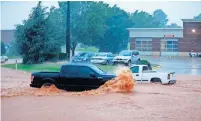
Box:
113;50;140;66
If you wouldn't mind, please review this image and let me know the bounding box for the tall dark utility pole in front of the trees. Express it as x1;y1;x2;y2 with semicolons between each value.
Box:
66;1;71;61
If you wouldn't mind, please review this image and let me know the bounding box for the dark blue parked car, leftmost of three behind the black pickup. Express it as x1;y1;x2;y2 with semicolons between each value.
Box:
71;52;95;63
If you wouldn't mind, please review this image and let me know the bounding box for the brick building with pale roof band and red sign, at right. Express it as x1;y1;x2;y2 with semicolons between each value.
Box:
128;19;201;56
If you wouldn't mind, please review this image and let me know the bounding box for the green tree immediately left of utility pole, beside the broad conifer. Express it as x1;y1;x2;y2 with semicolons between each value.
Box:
44;7;65;53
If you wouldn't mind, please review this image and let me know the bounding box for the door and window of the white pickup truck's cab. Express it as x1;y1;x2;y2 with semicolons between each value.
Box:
131;66;142;83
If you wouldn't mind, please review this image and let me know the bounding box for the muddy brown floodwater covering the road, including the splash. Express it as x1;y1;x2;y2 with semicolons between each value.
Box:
1;68;201;121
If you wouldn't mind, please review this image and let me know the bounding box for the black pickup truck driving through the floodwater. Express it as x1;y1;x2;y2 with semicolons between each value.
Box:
30;64;115;91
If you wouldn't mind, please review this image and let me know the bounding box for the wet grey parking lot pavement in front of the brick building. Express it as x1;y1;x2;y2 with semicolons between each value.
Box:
141;56;201;75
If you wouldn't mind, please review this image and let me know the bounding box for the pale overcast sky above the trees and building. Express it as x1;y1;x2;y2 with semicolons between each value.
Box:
0;1;201;30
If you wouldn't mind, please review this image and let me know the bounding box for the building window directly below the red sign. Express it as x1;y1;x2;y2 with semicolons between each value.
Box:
161;39;178;52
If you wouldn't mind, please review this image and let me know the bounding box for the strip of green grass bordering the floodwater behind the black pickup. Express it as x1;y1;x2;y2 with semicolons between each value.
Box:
1;64;115;72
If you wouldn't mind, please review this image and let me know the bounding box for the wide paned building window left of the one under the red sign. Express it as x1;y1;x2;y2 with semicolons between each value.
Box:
135;38;152;51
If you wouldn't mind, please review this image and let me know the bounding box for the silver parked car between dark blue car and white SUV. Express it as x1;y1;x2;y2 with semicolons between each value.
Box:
91;52;114;65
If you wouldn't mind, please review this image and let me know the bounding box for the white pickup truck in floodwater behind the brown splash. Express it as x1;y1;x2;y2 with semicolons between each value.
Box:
130;65;176;84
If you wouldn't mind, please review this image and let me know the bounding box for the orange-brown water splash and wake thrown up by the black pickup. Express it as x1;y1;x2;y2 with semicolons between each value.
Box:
1;67;135;97
